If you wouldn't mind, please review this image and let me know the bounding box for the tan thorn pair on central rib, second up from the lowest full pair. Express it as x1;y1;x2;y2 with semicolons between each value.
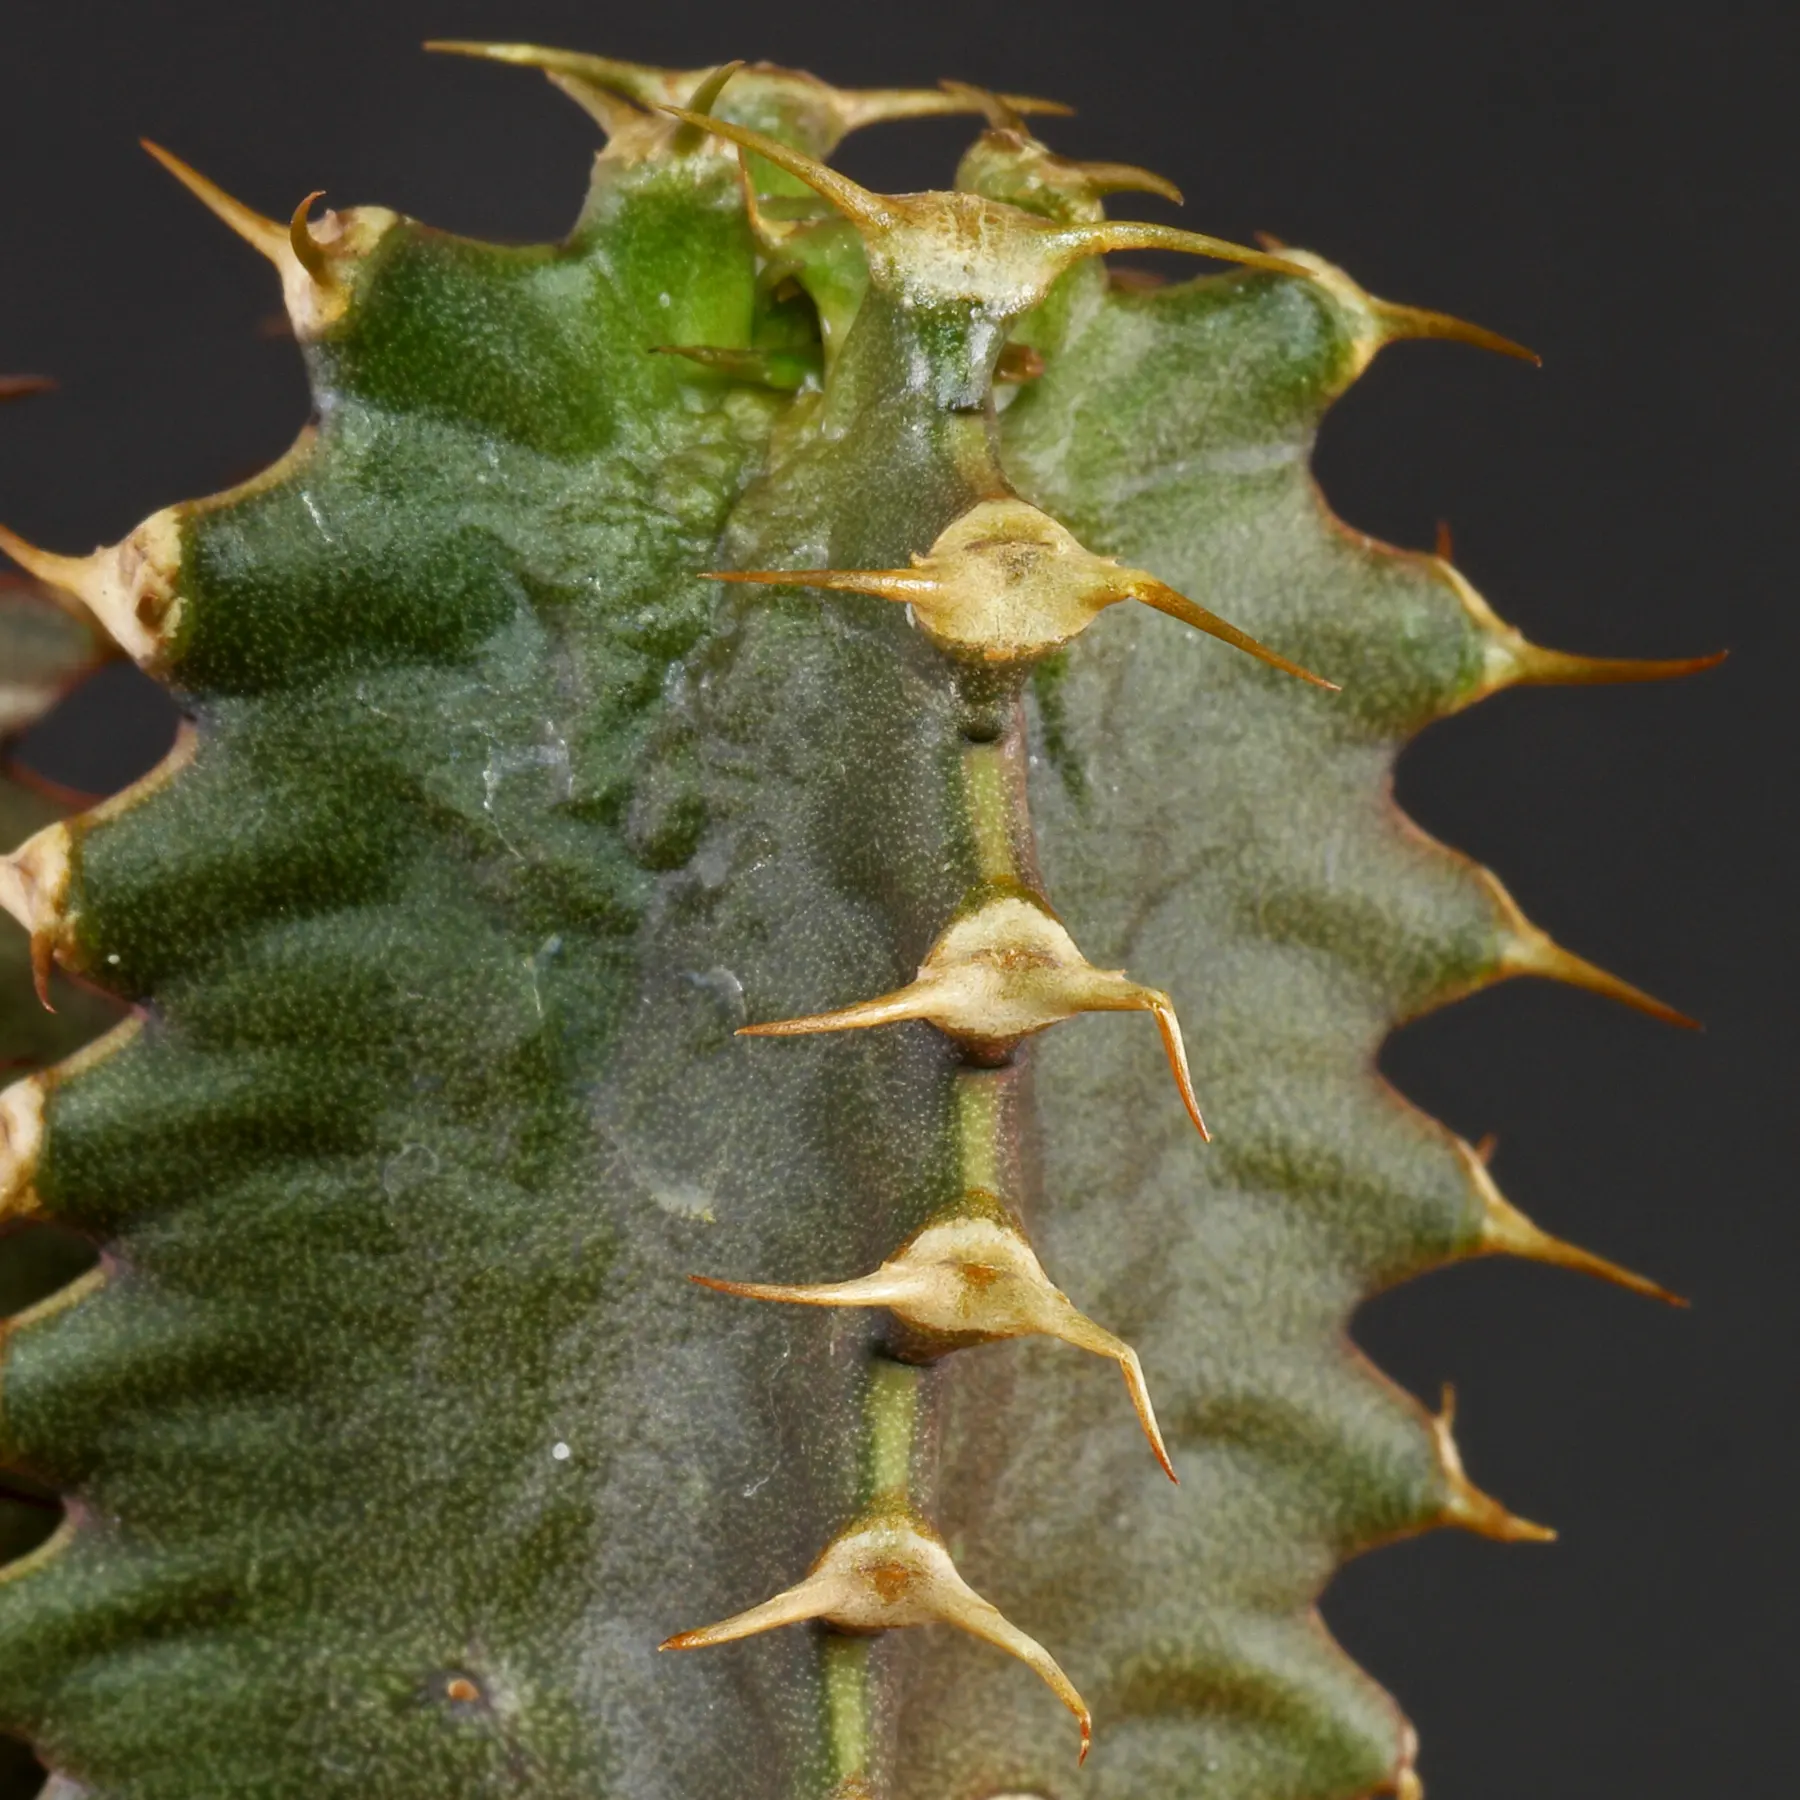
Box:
689;1190;1179;1481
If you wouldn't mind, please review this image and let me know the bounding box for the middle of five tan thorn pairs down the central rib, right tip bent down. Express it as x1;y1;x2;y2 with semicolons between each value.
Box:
738;893;1210;1138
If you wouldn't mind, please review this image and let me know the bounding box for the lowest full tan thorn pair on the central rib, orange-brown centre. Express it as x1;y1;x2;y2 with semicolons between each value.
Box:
659;1496;1093;1762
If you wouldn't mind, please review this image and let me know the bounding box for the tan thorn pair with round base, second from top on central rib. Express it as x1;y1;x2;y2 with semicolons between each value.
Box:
706;499;1336;693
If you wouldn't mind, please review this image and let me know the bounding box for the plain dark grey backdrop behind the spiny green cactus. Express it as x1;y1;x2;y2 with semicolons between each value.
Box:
0;0;1800;1800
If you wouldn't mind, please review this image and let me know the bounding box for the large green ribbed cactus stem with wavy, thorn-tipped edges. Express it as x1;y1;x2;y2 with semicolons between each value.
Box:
0;47;1706;1800
